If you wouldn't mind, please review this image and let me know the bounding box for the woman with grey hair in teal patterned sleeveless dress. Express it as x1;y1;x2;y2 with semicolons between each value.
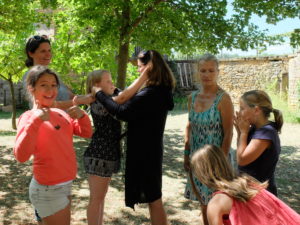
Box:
184;54;233;224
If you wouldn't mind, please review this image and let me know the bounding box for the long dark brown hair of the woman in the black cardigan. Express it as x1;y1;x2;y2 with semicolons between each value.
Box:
138;50;175;89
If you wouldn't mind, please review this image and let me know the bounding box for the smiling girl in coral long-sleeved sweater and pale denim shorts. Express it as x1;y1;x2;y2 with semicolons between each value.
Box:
14;66;92;225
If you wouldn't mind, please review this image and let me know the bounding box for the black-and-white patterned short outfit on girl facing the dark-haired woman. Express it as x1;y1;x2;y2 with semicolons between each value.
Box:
83;89;121;177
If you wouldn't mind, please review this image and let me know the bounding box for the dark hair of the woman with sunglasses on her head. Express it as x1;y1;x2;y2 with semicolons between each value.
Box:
25;35;51;67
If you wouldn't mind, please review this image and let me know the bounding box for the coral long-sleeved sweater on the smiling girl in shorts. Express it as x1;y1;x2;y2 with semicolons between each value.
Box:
14;108;92;185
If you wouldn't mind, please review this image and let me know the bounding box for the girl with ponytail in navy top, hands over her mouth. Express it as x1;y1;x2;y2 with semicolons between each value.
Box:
235;90;283;196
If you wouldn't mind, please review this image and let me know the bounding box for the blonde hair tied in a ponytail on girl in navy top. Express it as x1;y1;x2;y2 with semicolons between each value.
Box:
241;90;283;133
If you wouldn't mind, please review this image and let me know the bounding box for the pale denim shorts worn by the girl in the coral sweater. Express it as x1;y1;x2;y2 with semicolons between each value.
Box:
29;178;72;218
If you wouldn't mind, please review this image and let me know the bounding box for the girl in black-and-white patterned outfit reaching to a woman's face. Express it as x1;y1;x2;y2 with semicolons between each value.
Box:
82;70;147;225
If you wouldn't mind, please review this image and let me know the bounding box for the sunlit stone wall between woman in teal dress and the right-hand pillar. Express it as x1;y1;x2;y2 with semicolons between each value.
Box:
218;57;289;104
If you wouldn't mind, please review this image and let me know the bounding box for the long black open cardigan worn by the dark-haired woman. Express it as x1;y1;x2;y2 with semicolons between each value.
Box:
96;86;174;208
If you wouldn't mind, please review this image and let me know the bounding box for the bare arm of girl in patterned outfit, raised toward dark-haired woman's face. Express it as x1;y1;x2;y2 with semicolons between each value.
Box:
113;64;148;104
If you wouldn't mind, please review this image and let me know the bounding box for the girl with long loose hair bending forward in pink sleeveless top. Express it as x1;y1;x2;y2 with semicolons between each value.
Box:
191;145;300;225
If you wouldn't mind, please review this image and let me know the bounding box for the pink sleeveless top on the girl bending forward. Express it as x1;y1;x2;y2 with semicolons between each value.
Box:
221;189;300;225
